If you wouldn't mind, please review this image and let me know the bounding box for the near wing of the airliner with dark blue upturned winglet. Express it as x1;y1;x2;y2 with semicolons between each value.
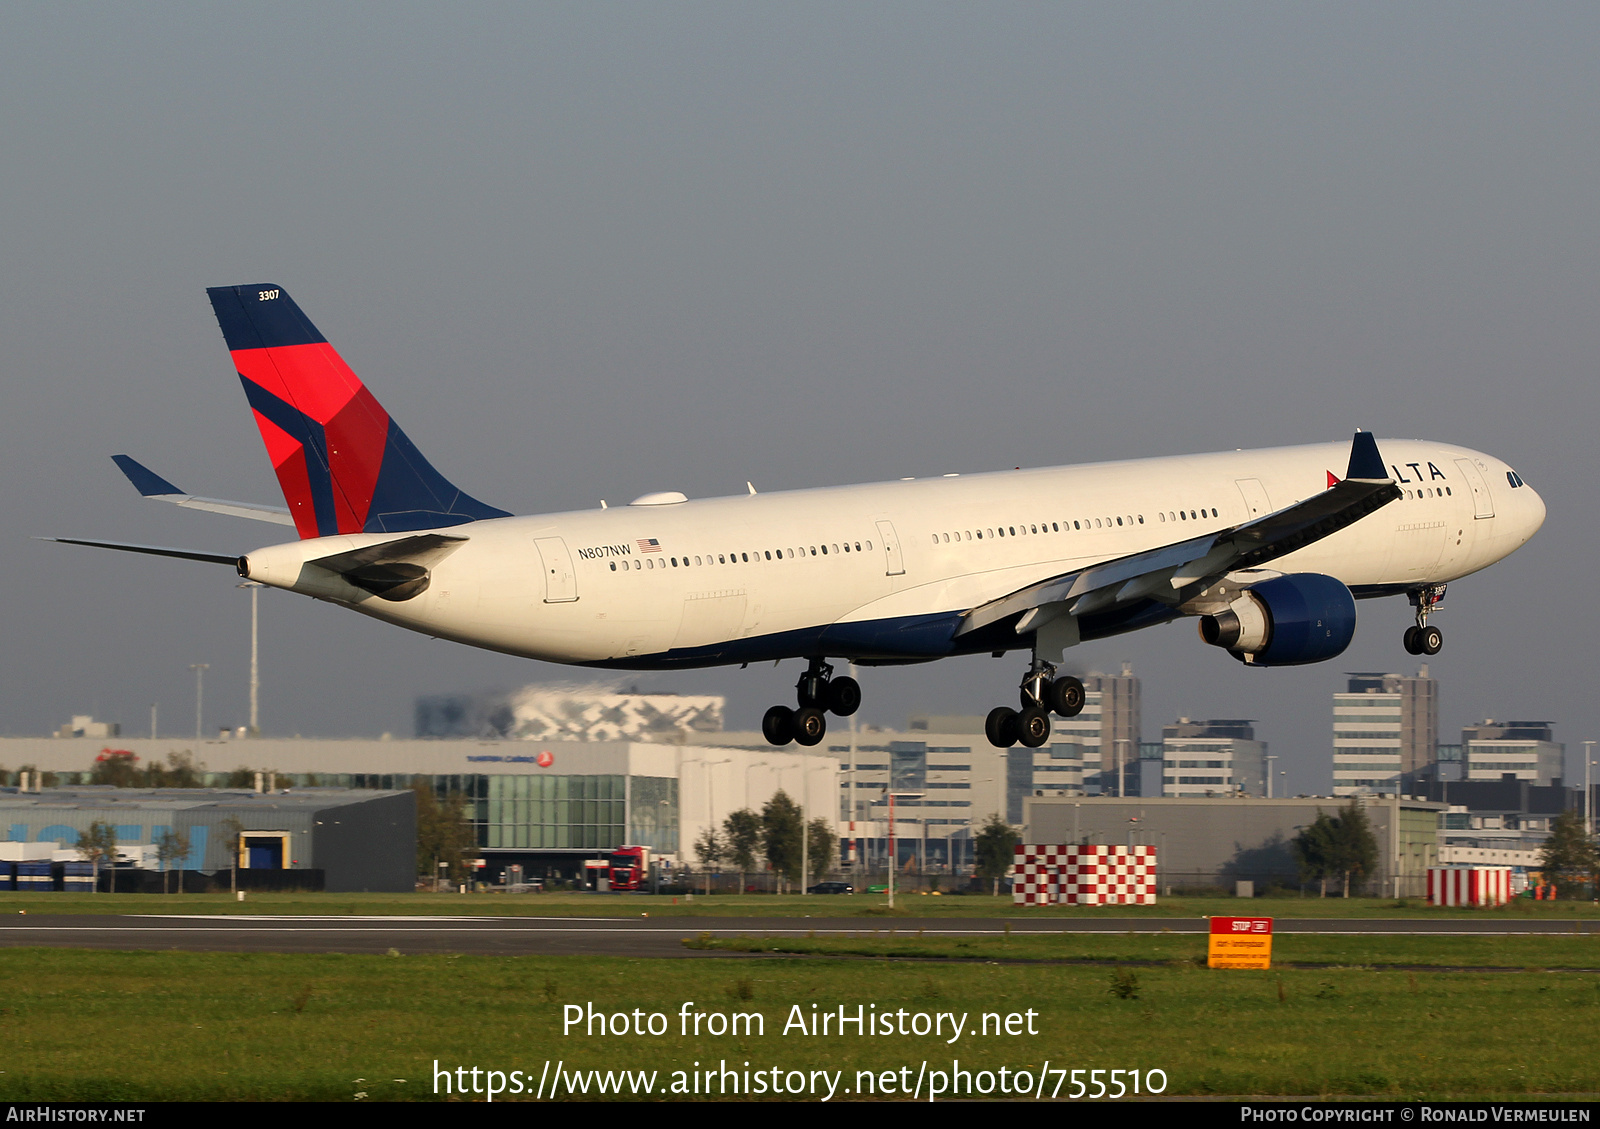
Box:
957;432;1400;636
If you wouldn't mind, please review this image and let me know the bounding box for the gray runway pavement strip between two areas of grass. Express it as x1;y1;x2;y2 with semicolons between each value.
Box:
0;915;1600;959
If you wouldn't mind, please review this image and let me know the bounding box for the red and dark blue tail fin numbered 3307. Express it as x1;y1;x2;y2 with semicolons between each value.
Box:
206;285;509;539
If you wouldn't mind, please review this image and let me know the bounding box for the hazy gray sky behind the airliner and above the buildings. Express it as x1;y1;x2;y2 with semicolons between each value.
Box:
0;3;1600;790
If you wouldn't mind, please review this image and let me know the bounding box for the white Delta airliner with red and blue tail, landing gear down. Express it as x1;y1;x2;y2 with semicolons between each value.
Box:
58;286;1544;747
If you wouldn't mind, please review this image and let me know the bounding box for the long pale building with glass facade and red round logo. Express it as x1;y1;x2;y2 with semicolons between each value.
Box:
0;737;838;878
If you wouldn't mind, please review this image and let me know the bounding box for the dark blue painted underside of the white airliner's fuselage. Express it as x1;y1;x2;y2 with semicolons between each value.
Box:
581;600;1178;670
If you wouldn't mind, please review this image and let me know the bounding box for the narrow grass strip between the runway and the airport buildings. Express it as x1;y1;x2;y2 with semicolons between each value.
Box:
0;892;1600;920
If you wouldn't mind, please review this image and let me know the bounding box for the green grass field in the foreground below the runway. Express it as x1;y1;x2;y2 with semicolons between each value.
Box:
0;936;1600;1102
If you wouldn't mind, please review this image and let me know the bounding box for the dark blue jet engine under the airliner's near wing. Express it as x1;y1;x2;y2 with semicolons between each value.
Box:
1200;572;1355;667
